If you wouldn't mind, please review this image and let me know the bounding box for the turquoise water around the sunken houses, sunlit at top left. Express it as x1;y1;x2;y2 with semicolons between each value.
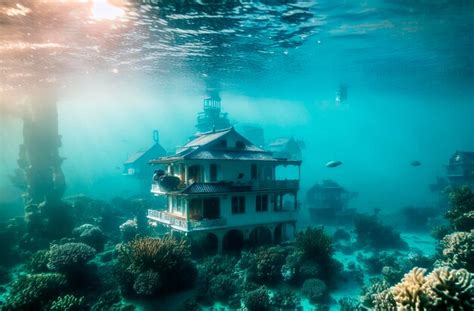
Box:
0;0;474;310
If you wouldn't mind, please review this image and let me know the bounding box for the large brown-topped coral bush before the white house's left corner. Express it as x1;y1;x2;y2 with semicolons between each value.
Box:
115;236;197;296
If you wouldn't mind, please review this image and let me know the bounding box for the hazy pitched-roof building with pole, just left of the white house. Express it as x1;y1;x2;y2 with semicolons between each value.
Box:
123;130;166;185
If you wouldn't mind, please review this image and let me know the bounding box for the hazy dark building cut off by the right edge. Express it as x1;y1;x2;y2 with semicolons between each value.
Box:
446;151;474;187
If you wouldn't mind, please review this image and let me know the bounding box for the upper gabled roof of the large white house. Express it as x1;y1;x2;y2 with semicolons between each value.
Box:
150;127;302;163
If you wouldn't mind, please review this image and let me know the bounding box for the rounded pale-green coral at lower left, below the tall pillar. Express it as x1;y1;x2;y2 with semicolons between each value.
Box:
47;243;95;272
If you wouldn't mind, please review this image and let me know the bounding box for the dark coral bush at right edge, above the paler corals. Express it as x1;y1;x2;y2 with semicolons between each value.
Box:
446;186;474;231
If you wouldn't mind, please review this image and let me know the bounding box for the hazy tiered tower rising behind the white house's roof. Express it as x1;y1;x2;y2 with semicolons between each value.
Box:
196;98;230;133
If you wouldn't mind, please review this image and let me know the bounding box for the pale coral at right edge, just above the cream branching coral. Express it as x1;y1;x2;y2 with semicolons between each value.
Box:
438;230;474;271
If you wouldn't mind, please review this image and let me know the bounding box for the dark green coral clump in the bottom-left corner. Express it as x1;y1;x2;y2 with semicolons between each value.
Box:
2;273;67;310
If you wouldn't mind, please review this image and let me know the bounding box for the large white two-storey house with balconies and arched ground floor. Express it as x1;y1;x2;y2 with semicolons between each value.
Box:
148;128;301;251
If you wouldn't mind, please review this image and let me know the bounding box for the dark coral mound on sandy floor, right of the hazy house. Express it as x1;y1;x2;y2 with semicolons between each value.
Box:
354;214;408;250
